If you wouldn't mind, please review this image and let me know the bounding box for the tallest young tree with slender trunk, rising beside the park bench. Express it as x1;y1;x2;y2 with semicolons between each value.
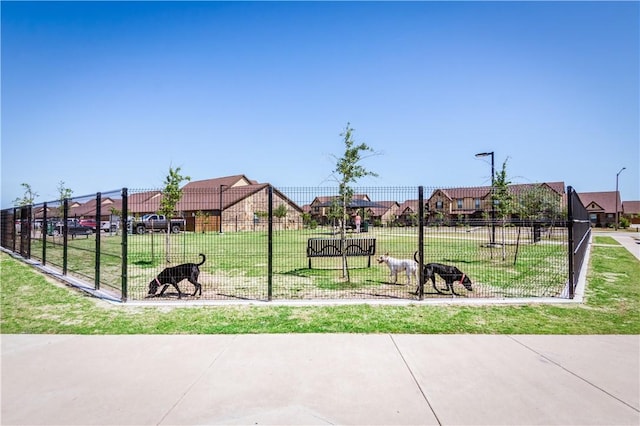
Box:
333;123;378;282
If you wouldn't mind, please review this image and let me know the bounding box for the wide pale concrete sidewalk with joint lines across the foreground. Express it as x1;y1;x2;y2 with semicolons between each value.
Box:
1;334;640;425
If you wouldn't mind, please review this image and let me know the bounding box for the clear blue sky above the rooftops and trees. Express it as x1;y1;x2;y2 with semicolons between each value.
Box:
1;1;640;207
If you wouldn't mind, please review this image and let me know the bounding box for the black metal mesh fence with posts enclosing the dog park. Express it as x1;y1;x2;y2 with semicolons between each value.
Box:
1;184;588;301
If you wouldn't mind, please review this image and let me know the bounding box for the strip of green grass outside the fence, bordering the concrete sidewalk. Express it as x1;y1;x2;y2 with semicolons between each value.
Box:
0;238;640;334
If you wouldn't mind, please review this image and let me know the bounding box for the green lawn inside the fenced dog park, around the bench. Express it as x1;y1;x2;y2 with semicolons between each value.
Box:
32;227;568;300
